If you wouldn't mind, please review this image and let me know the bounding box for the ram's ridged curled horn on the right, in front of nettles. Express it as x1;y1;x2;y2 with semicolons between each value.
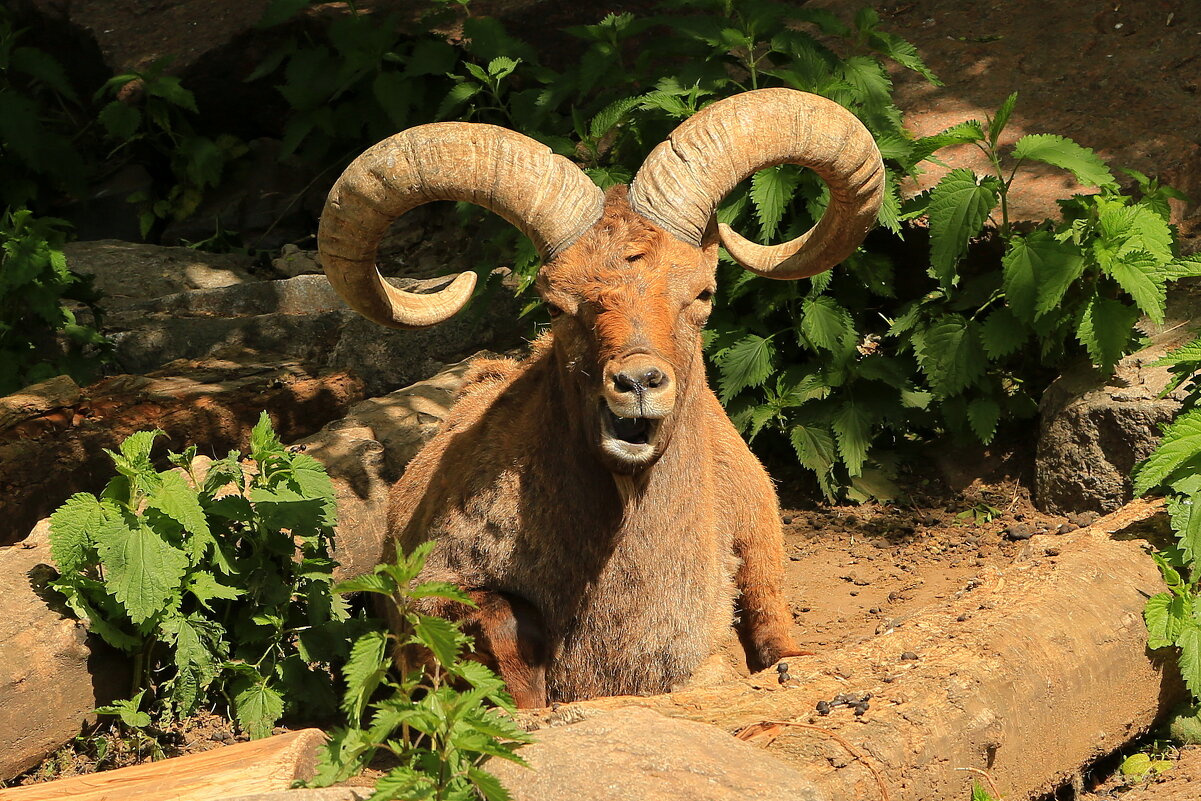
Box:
629;89;884;280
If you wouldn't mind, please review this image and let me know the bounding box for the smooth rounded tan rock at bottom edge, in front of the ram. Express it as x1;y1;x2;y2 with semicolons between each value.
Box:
488;707;827;801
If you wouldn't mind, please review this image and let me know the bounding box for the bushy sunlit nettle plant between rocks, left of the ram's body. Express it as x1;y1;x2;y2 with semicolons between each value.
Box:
50;413;355;737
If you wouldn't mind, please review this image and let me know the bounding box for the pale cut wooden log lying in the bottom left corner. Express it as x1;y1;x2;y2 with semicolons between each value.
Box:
0;729;325;801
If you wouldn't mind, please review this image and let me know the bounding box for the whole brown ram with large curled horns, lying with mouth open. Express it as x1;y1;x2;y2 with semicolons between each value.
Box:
319;89;884;706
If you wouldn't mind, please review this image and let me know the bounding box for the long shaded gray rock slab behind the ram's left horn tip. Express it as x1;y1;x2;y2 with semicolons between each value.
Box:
98;275;521;395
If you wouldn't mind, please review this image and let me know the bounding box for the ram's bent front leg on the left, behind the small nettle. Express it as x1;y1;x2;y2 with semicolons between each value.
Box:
388;587;550;709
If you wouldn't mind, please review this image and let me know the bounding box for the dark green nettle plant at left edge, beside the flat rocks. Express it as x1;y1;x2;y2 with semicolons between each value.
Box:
0;209;109;395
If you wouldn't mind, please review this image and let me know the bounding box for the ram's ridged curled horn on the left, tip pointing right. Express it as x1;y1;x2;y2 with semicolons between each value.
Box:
317;122;604;328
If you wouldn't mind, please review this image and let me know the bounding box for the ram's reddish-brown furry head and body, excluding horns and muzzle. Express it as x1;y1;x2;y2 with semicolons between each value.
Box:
388;187;799;705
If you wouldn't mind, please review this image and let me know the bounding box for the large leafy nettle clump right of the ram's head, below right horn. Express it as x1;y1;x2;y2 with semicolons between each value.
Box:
711;94;1201;500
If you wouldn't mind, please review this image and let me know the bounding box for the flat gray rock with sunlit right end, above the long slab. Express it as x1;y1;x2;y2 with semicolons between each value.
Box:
62;239;255;309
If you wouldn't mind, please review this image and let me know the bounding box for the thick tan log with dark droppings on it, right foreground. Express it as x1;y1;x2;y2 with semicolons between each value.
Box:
528;501;1183;801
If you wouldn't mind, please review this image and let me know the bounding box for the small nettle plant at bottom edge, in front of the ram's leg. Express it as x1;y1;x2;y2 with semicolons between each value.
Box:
313;543;530;801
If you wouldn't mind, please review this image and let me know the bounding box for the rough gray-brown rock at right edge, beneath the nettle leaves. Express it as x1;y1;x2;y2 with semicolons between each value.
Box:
1034;285;1201;515
